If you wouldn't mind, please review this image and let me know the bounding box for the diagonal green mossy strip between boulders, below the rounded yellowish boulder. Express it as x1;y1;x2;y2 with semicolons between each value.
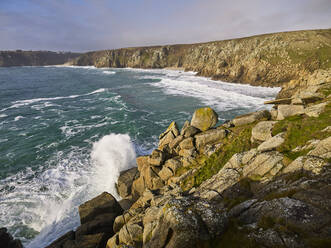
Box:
194;124;254;187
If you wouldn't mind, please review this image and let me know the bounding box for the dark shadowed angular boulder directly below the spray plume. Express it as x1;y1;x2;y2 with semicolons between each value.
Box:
78;192;123;224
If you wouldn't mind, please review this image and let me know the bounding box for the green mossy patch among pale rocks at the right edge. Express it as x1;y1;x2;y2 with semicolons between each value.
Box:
272;103;331;160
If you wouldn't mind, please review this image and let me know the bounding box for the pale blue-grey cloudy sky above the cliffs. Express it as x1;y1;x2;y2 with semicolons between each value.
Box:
0;0;331;52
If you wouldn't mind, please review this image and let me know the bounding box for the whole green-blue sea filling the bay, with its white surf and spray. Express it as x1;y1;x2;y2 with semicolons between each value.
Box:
0;66;280;248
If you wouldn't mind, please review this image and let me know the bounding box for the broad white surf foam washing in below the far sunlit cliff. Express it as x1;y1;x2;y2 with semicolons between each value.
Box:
134;69;280;111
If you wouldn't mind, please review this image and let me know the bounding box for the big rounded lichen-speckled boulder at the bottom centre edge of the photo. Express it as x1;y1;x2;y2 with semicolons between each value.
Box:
143;197;228;248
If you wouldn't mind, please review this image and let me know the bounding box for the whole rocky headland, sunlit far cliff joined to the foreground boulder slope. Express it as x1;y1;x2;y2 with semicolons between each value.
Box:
1;29;331;248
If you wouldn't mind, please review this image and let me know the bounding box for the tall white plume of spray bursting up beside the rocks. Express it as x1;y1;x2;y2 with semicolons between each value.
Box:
91;134;136;197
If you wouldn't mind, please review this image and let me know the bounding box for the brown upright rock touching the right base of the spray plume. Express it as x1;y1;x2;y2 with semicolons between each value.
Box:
116;167;139;198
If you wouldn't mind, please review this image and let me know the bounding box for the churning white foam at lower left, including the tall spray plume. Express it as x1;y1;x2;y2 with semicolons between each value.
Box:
0;134;136;248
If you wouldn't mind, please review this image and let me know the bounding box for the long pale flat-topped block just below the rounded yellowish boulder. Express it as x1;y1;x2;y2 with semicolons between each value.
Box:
194;128;227;150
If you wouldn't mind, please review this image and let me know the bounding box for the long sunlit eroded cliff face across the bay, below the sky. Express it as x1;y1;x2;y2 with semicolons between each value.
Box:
73;29;331;86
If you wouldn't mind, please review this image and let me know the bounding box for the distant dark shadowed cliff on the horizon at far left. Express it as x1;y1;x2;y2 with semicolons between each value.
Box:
0;50;81;67
